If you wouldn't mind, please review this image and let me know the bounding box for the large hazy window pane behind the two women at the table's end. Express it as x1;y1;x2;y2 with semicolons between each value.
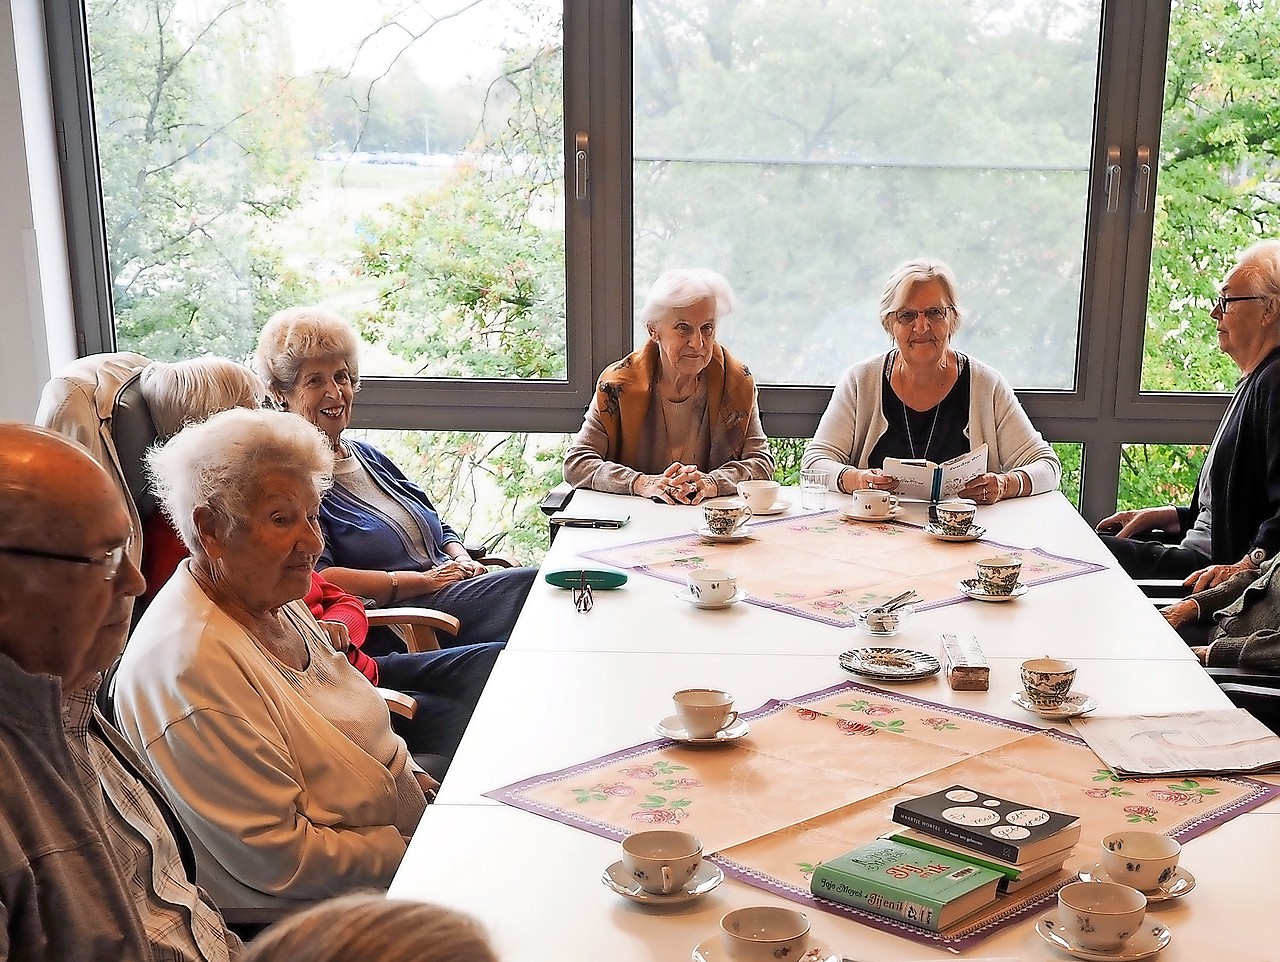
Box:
634;0;1101;389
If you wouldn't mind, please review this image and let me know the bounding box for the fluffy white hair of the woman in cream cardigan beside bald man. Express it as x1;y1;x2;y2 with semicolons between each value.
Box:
146;408;333;554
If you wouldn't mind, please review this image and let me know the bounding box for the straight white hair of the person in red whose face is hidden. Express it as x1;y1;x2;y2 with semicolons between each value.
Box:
138;357;266;443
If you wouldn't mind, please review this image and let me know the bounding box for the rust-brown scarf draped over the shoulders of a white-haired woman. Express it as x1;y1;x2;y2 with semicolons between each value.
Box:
595;340;755;471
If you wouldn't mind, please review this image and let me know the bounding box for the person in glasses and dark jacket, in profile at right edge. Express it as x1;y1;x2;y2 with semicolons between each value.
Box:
1098;241;1280;591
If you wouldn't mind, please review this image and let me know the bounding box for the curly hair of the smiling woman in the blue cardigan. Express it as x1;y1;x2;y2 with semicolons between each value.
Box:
253;304;360;394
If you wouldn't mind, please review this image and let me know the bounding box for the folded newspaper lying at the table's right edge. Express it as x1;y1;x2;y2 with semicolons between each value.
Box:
1071;709;1280;778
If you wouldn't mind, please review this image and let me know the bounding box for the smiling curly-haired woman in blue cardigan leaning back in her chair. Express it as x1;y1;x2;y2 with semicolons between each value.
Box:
253;307;536;645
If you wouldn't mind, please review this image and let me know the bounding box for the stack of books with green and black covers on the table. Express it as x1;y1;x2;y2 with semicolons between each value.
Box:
810;785;1080;931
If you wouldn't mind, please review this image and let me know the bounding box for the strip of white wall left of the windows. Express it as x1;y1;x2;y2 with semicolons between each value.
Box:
0;0;76;421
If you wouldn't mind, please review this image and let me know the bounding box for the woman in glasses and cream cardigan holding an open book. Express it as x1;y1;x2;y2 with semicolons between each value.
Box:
803;260;1062;504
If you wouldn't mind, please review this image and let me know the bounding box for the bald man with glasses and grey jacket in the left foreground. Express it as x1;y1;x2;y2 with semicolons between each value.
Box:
0;422;241;962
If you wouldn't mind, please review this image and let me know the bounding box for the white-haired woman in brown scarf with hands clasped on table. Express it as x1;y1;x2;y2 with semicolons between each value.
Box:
564;269;773;504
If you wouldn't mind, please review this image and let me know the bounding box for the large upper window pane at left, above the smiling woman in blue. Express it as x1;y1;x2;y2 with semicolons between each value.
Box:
87;0;566;379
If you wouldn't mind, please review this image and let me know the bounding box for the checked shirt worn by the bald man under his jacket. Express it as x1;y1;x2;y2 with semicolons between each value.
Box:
63;684;242;962
